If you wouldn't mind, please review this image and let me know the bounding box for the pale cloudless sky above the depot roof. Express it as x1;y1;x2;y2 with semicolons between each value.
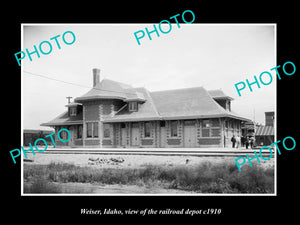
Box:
22;23;277;129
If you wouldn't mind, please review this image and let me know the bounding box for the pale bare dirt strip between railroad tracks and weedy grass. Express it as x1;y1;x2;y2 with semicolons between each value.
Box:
25;154;274;168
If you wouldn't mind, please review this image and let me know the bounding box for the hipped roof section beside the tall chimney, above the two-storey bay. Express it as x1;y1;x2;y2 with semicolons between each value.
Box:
75;79;144;102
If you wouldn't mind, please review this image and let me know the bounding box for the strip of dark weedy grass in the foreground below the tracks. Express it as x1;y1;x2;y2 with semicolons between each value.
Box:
23;161;274;194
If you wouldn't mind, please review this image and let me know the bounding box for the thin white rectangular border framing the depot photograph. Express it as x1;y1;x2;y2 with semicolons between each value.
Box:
20;23;277;197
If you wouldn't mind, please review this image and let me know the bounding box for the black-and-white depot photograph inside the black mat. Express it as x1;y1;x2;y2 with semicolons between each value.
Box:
20;22;276;195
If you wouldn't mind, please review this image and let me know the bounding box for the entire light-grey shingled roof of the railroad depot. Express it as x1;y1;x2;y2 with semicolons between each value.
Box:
42;79;250;126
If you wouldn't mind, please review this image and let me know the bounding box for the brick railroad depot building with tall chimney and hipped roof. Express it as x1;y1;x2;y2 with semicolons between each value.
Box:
41;69;249;148
